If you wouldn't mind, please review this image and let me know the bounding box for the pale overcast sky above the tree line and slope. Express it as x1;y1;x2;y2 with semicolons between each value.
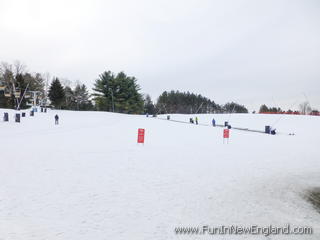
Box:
0;0;320;110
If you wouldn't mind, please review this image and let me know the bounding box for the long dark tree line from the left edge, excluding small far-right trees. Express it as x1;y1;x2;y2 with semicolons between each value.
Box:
0;62;248;114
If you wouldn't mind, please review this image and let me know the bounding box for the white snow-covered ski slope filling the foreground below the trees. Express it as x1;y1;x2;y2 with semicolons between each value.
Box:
0;110;320;240
